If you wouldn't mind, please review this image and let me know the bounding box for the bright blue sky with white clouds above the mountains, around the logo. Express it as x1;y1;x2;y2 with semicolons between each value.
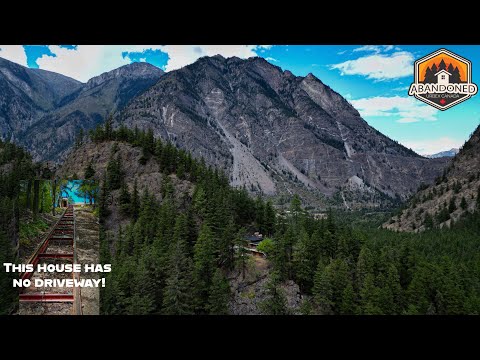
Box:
0;44;480;154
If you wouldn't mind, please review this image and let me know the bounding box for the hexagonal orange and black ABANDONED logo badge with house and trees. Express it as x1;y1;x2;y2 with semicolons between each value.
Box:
408;49;478;110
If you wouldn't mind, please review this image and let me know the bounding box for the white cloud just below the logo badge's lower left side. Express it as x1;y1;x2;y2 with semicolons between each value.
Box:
350;96;438;123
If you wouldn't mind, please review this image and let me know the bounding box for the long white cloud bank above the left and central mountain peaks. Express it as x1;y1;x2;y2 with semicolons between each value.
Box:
32;45;272;82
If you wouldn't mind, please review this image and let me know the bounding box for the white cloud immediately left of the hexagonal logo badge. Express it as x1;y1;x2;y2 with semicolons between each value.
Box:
330;51;414;80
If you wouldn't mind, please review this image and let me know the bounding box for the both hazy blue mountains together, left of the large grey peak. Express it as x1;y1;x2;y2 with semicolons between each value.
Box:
0;59;163;160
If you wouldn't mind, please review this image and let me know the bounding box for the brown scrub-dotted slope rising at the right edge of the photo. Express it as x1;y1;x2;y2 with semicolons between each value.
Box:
383;126;480;232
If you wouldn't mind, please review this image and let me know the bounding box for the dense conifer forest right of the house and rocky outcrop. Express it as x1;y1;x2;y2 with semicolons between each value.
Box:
271;203;480;315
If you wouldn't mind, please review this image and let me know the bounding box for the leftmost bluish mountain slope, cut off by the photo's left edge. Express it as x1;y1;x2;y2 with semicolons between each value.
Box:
0;58;82;140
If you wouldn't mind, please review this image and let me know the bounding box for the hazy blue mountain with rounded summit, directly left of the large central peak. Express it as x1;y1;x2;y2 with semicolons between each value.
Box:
19;63;163;160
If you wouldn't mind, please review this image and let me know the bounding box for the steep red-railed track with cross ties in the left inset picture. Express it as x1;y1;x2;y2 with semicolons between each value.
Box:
19;205;82;315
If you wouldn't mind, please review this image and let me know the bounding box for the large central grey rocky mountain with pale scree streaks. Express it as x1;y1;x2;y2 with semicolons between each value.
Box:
116;55;446;208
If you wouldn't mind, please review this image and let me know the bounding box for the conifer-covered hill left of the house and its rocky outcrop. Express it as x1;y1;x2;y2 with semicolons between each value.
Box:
71;122;275;314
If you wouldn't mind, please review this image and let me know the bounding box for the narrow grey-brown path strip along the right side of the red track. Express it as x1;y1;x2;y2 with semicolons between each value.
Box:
75;207;100;315
